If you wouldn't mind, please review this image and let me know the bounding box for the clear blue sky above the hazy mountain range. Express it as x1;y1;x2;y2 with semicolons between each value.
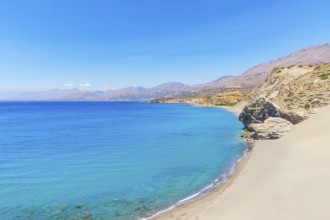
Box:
0;0;330;91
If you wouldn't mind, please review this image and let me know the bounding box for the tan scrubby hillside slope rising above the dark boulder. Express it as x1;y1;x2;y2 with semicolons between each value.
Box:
249;63;330;114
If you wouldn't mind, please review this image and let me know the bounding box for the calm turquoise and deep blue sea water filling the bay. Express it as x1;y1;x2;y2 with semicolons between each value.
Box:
0;102;246;220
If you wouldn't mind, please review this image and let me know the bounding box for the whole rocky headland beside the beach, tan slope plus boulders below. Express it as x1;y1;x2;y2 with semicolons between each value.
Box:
239;63;330;139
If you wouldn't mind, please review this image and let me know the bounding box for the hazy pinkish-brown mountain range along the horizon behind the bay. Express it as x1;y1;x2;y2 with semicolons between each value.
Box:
0;43;330;101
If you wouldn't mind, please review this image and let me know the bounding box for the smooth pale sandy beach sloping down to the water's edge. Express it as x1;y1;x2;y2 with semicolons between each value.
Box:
154;106;330;220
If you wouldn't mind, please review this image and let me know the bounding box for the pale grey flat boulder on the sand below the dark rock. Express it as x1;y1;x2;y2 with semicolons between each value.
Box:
248;117;292;140
